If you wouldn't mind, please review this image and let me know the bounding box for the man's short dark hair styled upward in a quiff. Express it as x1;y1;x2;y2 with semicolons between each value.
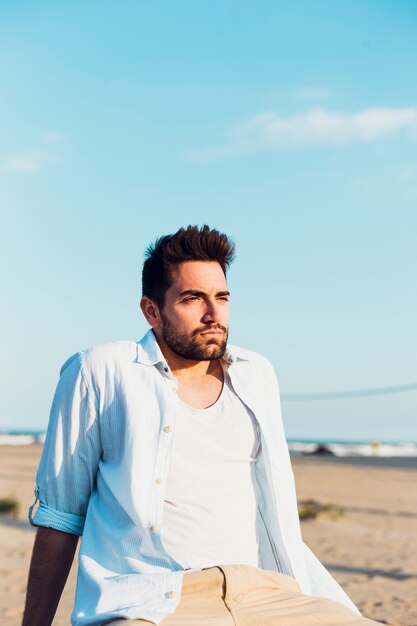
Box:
142;225;235;309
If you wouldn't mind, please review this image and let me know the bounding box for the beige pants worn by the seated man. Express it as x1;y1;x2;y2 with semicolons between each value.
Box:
108;565;377;626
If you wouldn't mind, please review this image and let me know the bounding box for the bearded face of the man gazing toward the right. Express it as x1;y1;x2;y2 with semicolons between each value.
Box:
159;261;229;361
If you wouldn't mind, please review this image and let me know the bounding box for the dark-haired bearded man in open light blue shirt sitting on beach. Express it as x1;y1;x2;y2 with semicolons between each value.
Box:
23;226;380;626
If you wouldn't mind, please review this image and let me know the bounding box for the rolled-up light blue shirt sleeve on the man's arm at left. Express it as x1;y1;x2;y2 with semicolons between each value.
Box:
29;352;101;535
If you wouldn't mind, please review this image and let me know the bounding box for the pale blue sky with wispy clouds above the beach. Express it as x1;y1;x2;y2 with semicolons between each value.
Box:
0;0;417;440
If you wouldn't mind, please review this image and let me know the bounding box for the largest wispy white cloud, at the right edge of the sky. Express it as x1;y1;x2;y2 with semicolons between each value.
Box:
188;107;417;161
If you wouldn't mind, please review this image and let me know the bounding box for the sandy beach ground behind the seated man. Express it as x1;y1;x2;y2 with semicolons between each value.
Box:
0;445;417;626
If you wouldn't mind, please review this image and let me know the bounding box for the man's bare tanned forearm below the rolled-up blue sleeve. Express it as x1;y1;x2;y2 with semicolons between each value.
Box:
22;526;78;626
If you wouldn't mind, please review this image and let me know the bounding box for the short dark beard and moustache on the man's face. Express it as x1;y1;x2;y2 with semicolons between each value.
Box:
161;311;228;361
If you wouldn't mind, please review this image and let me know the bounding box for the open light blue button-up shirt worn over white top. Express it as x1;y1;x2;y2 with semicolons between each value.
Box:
29;331;355;626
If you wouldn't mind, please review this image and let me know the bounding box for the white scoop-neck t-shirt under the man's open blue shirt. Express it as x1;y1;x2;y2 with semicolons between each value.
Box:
162;372;259;569
